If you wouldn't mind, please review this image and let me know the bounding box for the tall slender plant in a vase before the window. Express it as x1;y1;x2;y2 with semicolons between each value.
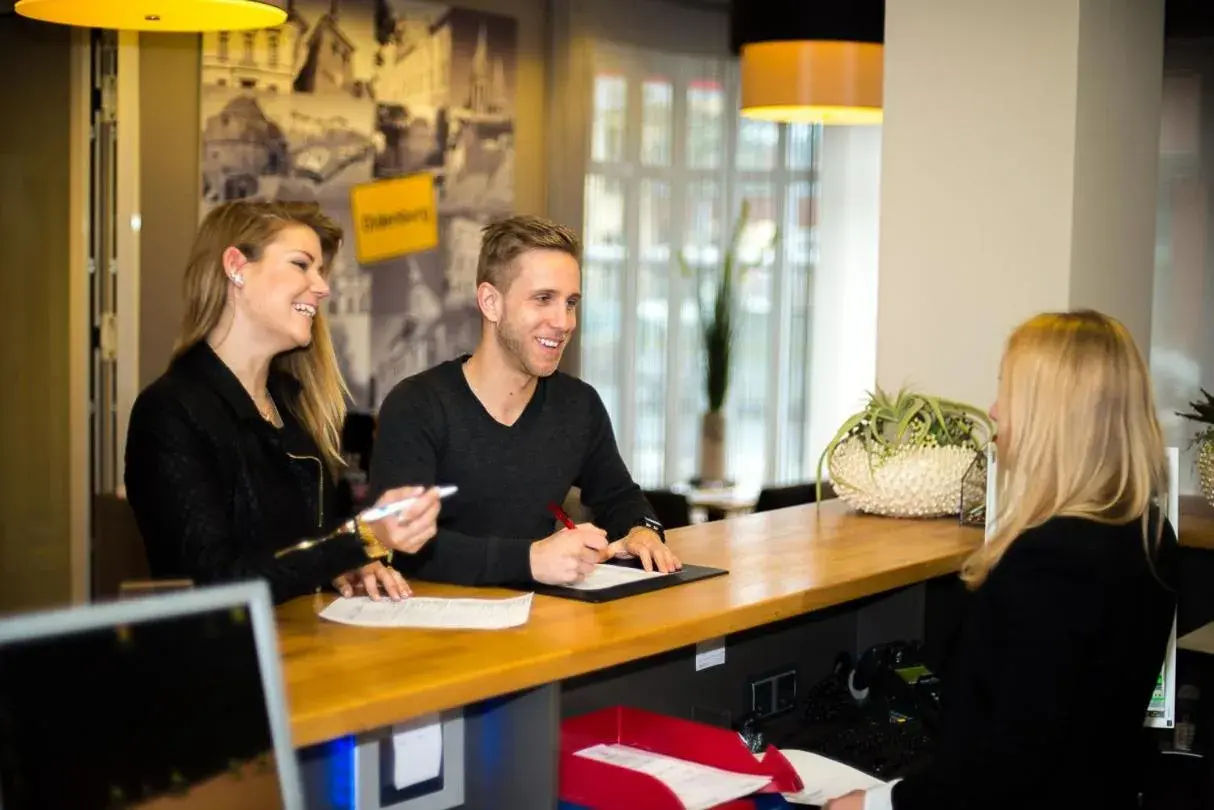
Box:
676;199;778;486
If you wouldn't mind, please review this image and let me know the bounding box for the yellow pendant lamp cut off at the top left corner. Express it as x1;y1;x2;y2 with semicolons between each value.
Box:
15;0;287;33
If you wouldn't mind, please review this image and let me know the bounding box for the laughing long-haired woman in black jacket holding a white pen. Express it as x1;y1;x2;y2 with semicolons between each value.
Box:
125;200;438;602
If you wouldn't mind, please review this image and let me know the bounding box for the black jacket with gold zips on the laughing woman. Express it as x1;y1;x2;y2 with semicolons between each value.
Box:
125;341;368;602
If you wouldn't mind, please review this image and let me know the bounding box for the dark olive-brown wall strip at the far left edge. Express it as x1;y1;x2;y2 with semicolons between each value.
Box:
0;16;87;611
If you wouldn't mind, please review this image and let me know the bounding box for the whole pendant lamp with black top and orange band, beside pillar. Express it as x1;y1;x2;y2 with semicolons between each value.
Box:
730;0;885;125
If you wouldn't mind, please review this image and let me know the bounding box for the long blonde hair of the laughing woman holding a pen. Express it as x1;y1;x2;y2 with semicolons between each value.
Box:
174;200;348;472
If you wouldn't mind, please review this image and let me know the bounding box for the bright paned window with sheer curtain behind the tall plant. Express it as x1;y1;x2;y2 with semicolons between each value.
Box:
579;41;819;488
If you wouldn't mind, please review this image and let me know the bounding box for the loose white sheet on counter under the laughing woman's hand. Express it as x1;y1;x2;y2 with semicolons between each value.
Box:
320;594;532;630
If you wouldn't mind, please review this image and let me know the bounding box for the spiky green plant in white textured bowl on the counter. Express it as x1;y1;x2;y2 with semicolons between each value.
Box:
817;386;993;517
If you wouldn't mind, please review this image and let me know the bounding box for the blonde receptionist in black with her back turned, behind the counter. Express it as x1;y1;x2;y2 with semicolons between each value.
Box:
827;311;1175;810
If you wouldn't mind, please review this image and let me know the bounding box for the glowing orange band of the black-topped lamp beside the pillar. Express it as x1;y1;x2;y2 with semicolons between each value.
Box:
742;40;884;124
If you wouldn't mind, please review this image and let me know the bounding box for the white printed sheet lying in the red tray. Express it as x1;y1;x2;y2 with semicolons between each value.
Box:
575;743;771;810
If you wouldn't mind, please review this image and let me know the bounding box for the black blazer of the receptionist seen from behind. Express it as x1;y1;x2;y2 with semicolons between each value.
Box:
894;517;1176;810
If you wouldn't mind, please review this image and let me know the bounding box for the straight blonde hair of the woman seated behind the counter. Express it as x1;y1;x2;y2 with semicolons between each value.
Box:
961;310;1169;588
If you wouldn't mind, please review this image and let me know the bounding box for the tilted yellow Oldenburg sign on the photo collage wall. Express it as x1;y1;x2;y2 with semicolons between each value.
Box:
350;172;438;265
